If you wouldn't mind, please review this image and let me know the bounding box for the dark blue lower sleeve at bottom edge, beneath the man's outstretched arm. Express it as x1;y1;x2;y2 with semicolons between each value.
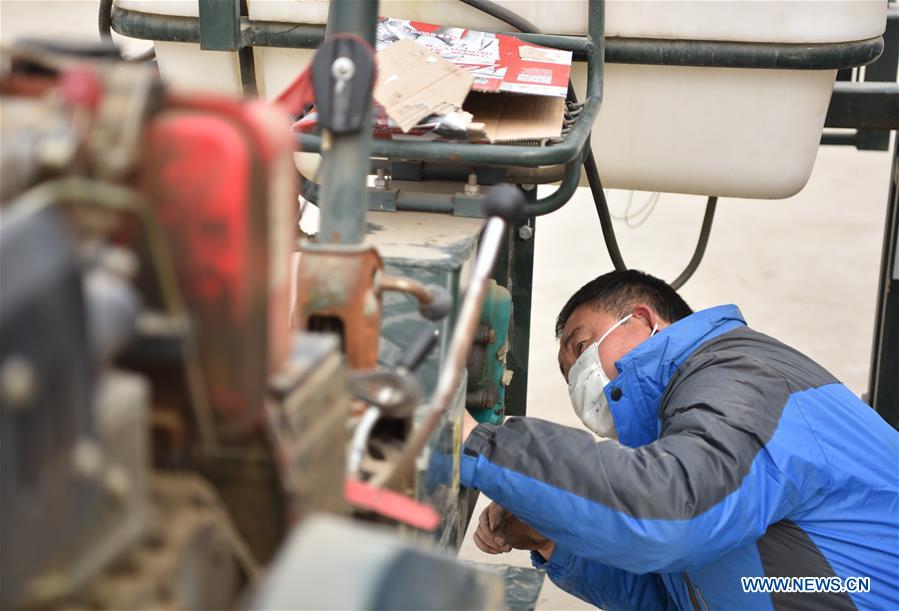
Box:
531;545;676;611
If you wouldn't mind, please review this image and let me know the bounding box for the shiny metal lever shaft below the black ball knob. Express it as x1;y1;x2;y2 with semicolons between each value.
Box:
381;217;506;491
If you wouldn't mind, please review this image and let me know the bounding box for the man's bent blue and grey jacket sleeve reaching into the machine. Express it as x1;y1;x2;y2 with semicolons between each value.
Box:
462;356;828;574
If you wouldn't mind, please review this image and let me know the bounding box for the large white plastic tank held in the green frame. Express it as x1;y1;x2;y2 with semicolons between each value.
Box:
116;0;886;198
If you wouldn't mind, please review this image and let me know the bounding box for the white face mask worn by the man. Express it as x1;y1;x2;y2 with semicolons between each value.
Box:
568;314;658;439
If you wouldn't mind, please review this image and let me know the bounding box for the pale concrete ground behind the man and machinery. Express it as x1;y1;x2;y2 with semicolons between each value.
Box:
0;0;890;610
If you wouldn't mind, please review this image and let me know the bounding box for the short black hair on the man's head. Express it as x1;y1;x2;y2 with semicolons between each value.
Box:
556;269;693;339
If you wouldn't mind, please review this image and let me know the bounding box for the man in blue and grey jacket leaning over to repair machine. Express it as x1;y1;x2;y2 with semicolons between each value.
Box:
462;271;899;609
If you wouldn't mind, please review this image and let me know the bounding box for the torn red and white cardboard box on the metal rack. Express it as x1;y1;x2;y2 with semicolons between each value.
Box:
375;17;571;143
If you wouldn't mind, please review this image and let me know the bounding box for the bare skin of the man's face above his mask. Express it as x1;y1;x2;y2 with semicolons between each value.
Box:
559;305;668;380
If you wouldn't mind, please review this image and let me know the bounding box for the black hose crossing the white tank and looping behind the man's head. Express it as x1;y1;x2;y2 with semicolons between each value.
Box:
460;0;718;289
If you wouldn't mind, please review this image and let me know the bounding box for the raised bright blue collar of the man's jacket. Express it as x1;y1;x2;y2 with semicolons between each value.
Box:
605;305;746;448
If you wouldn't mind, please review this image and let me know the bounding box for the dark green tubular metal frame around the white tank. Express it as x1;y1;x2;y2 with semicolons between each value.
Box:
112;0;884;216
